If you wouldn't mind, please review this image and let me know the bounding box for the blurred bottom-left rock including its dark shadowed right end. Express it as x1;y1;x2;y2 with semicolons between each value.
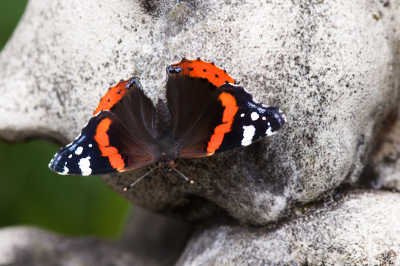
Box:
0;208;192;266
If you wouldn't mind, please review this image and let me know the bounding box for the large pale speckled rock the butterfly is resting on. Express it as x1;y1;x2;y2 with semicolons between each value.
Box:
0;0;400;225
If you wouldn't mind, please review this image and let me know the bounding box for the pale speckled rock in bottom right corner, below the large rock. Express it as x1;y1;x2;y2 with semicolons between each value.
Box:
176;191;400;266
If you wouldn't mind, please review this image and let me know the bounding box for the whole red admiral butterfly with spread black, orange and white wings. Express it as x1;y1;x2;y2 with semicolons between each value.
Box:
49;58;286;190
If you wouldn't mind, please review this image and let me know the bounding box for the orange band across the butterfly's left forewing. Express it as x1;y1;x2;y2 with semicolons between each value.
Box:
94;118;125;169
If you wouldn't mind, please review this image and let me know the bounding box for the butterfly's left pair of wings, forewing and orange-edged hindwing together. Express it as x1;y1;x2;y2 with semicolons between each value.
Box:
49;78;155;175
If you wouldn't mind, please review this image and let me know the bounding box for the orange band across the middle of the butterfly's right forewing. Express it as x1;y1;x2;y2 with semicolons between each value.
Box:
207;92;239;153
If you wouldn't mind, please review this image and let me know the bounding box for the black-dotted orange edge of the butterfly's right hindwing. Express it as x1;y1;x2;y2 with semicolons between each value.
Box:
171;59;235;87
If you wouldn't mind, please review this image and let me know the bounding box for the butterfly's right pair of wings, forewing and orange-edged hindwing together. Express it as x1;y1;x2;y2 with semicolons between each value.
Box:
167;59;286;158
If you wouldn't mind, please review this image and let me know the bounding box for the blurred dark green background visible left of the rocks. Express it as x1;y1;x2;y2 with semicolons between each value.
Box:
0;0;131;239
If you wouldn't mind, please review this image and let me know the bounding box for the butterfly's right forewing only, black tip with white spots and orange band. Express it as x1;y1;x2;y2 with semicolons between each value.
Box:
178;84;286;158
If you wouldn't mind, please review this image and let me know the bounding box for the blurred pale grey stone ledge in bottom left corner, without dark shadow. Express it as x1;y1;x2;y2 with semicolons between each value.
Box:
0;227;158;266
